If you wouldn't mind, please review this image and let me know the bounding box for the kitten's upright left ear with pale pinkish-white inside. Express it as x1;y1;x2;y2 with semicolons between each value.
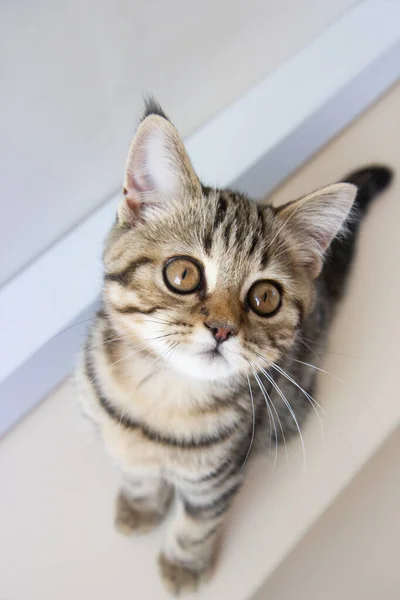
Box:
118;109;201;226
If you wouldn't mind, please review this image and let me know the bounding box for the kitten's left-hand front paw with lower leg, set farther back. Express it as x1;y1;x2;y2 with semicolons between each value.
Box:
115;476;173;535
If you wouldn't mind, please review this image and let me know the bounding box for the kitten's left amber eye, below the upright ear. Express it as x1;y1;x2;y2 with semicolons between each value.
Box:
163;256;203;294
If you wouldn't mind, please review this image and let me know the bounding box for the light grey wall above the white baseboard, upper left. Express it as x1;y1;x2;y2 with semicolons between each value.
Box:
0;0;356;283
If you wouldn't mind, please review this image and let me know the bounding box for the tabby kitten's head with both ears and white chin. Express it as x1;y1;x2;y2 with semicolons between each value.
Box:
104;98;356;379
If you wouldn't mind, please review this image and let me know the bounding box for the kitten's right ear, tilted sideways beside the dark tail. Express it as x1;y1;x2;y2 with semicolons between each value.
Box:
277;183;357;278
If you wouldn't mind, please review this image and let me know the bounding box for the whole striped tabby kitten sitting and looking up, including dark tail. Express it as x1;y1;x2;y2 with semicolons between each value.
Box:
78;102;391;595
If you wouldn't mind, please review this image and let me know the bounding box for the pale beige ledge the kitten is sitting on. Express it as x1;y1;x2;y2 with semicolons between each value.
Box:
0;86;400;600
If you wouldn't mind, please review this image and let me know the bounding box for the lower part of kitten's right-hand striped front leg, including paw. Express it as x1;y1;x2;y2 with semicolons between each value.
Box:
159;473;243;596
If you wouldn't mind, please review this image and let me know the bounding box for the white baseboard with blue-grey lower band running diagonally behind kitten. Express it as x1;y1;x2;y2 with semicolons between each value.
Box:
0;0;400;435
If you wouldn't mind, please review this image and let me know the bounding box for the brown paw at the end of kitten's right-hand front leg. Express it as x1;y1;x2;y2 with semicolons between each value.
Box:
158;554;211;597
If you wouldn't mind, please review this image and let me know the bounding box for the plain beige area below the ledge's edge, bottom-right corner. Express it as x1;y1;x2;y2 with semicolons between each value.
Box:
253;430;400;600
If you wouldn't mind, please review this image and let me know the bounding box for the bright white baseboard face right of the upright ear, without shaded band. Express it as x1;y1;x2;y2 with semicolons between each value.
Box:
188;0;400;187
